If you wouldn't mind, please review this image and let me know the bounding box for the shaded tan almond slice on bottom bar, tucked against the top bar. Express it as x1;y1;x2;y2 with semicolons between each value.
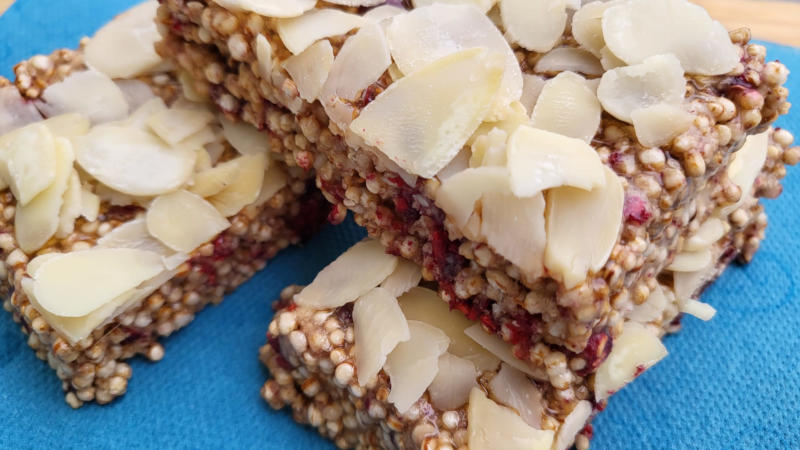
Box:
398;287;500;372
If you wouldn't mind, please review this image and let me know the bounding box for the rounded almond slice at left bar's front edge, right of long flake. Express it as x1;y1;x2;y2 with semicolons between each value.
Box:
147;190;230;253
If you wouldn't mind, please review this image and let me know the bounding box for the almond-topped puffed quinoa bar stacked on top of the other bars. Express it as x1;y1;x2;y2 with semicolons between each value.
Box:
156;0;800;358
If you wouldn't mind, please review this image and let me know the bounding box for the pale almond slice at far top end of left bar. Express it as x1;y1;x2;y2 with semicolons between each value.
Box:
84;0;162;78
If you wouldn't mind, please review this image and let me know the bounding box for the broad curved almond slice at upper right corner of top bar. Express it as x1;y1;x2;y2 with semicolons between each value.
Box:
603;0;739;75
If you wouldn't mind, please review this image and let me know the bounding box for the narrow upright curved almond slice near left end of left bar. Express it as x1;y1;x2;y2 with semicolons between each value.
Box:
14;138;75;254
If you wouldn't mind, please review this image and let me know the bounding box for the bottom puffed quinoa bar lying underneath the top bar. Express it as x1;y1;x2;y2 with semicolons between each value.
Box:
260;182;765;450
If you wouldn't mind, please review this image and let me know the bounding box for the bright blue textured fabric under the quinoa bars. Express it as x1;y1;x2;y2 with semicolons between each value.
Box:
0;0;800;450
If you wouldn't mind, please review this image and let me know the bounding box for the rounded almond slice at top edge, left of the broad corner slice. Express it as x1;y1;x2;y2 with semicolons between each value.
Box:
500;0;567;53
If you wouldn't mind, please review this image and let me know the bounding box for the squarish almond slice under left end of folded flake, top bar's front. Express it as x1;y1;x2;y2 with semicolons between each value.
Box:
481;193;547;280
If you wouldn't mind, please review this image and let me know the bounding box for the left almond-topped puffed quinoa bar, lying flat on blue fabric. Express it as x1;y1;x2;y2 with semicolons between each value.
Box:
0;4;328;408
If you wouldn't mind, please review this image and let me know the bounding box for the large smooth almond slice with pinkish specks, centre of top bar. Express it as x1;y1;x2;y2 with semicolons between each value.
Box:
350;49;502;178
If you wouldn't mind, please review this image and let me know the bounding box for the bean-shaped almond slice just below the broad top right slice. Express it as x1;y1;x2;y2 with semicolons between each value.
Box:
597;55;686;123
